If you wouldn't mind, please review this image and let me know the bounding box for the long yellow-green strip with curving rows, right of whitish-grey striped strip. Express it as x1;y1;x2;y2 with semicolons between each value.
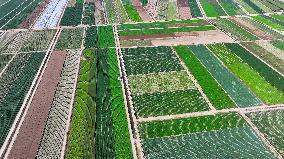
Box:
66;51;97;158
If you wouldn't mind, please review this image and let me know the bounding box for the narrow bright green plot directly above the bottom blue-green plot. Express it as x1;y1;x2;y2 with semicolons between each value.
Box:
139;113;248;139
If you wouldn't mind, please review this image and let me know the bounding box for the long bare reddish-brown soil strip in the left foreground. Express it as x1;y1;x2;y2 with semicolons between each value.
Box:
8;52;66;159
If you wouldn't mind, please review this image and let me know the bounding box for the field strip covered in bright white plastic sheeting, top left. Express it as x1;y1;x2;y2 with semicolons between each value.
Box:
33;0;68;29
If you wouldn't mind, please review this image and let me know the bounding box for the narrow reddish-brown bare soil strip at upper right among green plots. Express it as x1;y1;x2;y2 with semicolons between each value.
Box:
229;17;275;40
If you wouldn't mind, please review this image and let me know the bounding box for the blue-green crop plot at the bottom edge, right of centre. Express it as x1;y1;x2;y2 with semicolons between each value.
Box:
143;127;275;159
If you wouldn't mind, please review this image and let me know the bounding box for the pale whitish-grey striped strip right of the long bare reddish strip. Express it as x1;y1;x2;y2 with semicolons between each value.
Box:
37;50;80;158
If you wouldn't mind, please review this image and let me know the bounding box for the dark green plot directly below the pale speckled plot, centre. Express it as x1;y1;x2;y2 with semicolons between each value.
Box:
132;89;208;117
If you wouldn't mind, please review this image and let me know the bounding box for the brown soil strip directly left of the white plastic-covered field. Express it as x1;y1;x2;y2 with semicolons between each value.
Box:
19;0;51;28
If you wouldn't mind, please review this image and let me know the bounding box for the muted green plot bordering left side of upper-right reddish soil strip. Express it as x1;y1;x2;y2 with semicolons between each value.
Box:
210;18;258;41
